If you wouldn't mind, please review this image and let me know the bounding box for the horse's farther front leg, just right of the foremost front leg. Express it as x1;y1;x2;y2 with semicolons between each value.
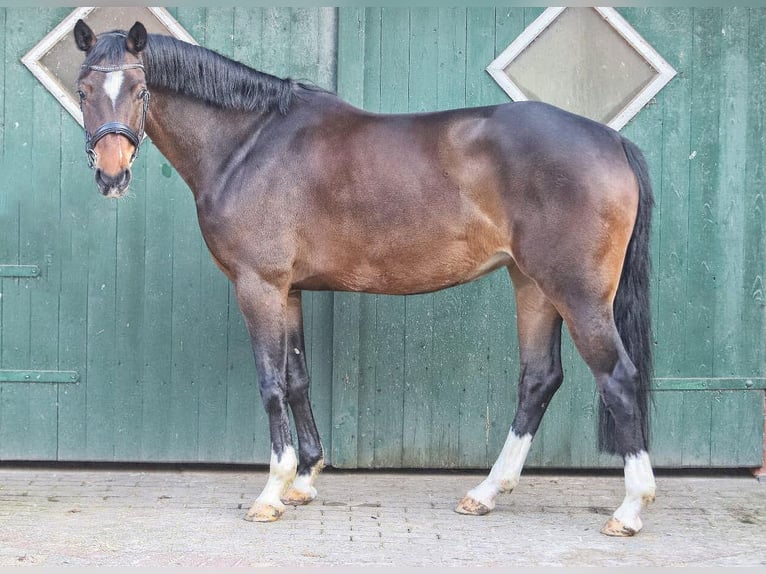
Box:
282;291;324;504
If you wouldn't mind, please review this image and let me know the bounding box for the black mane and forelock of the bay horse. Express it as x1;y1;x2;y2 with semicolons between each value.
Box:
84;31;300;114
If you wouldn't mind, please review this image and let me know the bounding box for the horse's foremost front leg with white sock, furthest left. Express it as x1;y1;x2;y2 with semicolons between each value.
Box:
236;275;298;522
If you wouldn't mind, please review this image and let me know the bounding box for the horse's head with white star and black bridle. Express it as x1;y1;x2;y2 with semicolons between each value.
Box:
74;20;149;198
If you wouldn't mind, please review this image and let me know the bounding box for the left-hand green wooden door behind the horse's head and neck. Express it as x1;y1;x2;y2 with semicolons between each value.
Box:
0;8;335;462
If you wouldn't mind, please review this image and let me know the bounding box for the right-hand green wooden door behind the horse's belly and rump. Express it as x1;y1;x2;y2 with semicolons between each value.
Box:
333;8;766;467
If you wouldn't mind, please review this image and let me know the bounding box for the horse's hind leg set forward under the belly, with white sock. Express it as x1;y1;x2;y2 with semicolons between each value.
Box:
455;268;564;515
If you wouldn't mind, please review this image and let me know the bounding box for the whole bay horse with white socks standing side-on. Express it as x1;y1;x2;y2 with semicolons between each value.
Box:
74;20;655;536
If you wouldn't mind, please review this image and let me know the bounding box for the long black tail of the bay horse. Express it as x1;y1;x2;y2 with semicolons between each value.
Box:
598;138;654;454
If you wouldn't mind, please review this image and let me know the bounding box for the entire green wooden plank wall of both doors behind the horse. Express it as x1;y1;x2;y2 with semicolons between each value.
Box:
0;7;766;467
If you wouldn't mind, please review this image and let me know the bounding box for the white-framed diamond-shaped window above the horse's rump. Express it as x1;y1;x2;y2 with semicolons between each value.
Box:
487;8;676;130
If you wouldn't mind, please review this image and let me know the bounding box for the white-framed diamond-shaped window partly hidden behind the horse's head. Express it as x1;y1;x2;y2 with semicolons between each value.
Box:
21;6;197;126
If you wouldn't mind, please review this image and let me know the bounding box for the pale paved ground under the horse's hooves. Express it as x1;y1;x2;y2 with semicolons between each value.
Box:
0;464;766;567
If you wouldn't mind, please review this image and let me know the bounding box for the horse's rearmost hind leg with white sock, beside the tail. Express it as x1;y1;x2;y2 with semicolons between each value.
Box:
566;303;655;536
